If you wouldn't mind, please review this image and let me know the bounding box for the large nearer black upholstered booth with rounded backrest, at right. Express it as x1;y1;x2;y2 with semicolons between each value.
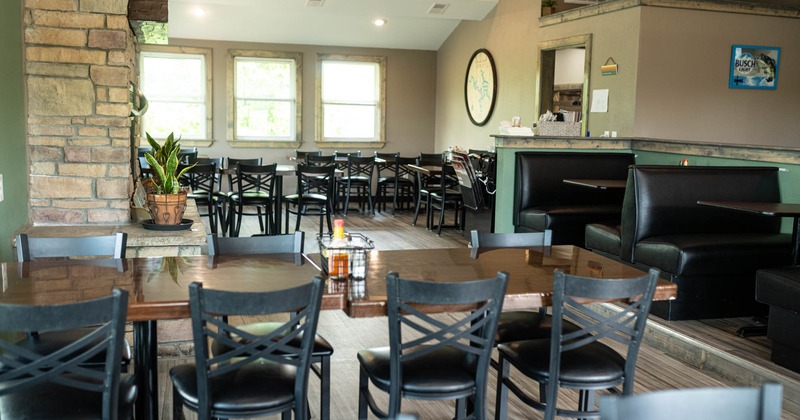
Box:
586;165;791;320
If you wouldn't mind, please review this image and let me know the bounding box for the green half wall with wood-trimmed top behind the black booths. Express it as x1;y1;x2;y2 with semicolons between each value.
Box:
495;148;800;233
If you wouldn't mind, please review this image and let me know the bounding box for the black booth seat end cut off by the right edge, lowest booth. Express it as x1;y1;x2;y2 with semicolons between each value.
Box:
756;266;800;312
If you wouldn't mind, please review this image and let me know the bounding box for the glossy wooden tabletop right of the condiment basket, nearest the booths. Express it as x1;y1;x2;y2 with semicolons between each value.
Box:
309;245;678;318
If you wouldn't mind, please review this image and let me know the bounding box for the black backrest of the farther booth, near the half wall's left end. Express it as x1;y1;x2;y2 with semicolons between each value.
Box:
514;152;634;226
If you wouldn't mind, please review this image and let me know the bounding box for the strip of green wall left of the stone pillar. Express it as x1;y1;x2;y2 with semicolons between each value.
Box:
0;0;28;261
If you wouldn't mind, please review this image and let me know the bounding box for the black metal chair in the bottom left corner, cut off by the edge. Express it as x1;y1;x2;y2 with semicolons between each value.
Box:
0;289;136;419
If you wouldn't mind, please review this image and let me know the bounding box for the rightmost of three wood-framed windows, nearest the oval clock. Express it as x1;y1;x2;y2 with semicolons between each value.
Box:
317;54;386;147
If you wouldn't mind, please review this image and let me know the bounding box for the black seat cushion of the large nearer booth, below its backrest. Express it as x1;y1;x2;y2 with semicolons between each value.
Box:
635;233;791;276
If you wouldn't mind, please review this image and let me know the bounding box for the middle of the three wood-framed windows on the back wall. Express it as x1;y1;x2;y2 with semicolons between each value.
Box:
228;50;302;147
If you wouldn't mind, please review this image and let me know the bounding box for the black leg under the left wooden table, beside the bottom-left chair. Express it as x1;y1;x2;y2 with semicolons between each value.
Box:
133;321;158;420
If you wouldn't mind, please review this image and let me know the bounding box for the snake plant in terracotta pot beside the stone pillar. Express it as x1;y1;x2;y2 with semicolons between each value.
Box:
144;133;194;225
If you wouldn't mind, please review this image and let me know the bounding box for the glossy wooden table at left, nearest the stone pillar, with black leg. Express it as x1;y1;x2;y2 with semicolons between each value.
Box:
0;254;328;419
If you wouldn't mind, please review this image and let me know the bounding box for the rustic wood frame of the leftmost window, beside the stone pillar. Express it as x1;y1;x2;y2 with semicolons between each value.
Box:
137;44;214;147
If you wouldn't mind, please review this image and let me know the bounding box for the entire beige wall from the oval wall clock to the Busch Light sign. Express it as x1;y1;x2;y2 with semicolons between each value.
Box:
436;0;800;150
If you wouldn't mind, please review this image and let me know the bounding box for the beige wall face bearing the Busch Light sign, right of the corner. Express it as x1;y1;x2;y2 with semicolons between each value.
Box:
633;8;800;146
